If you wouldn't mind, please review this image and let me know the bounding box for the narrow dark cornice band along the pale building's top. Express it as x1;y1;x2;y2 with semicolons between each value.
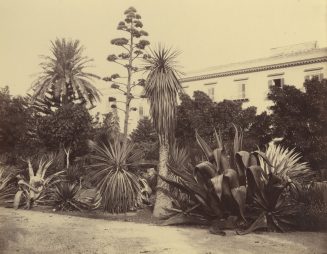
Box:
180;56;327;83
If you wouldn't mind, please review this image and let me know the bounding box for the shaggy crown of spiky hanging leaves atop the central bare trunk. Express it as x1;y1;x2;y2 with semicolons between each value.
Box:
144;45;183;142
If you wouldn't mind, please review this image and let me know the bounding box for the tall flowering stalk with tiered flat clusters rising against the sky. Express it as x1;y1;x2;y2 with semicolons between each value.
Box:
104;7;150;144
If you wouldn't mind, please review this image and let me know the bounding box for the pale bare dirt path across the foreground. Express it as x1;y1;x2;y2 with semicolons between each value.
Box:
0;207;327;254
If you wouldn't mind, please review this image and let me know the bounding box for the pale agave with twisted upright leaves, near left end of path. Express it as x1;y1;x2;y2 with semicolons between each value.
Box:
14;157;63;209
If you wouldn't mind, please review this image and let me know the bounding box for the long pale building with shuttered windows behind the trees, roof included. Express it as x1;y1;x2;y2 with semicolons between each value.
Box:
131;42;327;129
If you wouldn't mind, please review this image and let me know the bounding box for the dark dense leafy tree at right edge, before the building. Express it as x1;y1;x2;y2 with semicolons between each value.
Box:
268;79;327;169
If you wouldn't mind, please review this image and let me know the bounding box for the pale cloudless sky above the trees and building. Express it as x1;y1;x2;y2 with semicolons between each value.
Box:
0;0;327;98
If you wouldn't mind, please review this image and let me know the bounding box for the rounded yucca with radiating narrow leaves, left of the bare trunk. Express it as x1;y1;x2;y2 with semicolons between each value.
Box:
89;139;143;213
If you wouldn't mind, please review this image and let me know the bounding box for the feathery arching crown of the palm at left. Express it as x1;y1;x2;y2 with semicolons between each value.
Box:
32;39;100;106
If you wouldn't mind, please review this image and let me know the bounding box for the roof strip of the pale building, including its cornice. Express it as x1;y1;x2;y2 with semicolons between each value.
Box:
181;41;327;82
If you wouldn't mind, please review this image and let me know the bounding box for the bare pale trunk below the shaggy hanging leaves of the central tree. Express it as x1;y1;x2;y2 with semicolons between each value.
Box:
153;141;172;218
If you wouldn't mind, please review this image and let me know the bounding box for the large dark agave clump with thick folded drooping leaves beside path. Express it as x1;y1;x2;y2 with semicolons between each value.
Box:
160;126;299;234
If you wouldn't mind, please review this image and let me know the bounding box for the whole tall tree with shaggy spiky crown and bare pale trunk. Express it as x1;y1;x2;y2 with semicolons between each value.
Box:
145;46;182;217
